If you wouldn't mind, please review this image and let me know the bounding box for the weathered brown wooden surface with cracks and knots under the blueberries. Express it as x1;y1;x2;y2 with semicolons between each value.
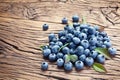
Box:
0;0;120;80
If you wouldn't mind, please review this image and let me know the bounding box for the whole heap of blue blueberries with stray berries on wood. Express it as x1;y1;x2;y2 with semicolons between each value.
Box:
41;15;116;71
